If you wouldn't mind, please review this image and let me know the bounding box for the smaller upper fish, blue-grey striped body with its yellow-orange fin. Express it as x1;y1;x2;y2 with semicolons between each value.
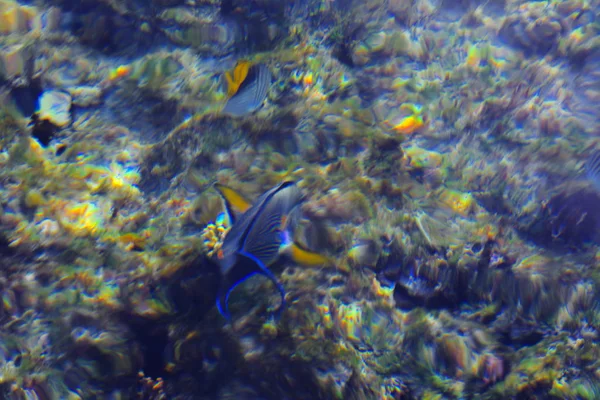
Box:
222;61;272;117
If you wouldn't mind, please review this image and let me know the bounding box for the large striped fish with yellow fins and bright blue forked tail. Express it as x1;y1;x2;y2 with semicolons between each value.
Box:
215;181;330;319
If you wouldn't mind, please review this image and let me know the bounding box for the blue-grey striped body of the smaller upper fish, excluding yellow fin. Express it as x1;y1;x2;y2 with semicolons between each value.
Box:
223;64;272;117
